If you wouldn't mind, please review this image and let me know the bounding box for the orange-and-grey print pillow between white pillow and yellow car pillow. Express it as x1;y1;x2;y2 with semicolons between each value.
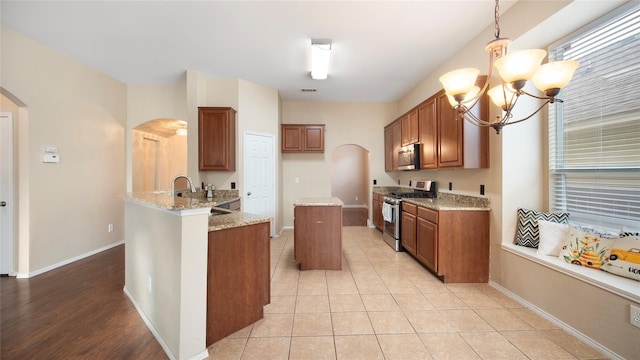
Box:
559;225;616;269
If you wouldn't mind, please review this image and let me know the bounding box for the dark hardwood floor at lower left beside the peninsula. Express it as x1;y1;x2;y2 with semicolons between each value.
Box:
0;245;167;360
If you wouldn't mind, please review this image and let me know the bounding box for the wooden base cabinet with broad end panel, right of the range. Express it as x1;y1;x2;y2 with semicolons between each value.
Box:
416;204;489;283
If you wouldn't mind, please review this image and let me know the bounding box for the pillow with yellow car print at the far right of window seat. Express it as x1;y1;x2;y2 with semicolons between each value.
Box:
602;236;640;281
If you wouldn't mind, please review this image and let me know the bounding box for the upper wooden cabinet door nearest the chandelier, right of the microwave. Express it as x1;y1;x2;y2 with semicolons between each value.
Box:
436;91;464;167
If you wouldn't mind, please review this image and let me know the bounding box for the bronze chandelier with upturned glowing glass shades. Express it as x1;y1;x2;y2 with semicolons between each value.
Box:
439;0;579;134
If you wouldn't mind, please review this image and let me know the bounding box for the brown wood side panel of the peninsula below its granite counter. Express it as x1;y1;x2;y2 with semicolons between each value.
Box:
206;222;271;346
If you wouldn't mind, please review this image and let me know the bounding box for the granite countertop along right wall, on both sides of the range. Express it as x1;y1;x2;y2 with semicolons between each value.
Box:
373;186;491;211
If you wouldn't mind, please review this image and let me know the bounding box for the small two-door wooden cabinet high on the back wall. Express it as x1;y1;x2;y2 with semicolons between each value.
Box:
282;124;324;153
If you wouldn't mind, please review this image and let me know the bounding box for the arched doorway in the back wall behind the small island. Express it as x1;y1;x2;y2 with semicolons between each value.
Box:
331;144;369;226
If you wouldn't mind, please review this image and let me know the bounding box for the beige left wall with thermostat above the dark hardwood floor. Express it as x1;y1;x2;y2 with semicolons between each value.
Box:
1;25;126;275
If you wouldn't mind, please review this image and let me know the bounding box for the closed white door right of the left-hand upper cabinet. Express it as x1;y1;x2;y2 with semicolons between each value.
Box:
242;132;276;237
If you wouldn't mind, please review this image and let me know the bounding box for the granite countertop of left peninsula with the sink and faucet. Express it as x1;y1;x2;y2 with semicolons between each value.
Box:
124;190;271;231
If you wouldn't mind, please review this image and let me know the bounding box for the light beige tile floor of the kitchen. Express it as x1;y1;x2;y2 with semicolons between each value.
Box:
209;227;605;360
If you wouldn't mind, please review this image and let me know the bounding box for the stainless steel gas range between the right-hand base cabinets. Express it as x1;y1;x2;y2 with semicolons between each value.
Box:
382;180;437;251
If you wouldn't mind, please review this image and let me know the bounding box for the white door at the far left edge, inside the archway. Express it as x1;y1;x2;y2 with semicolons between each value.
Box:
0;113;15;274
